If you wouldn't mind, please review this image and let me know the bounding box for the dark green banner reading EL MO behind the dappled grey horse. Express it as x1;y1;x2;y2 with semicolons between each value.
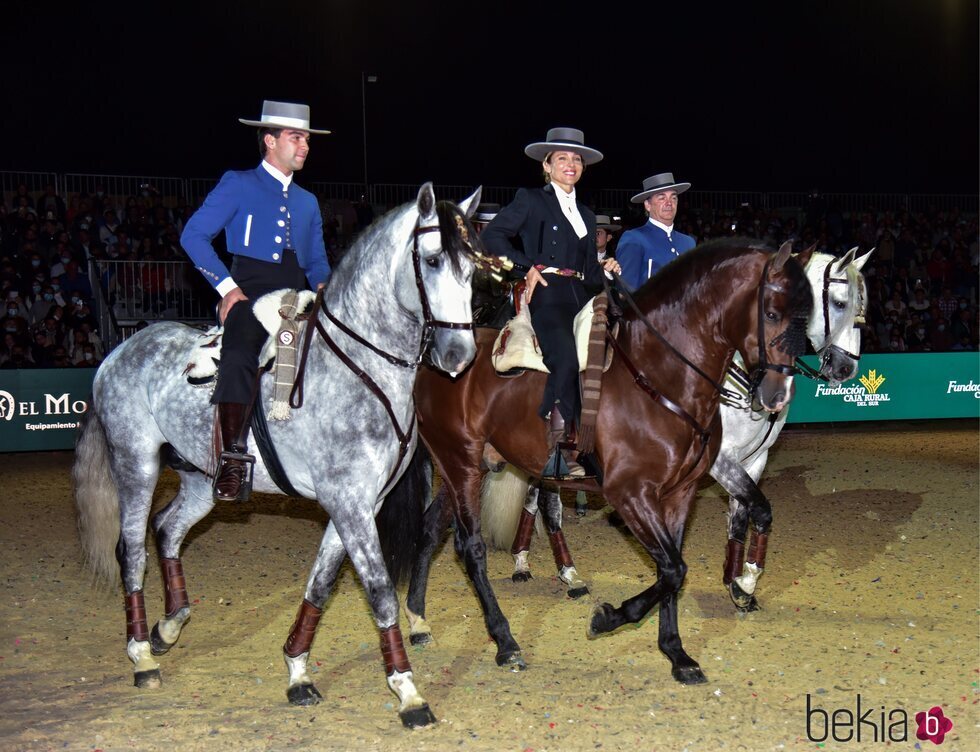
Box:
0;368;95;452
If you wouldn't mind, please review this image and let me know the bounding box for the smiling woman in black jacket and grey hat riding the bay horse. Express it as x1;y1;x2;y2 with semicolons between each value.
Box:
481;128;619;477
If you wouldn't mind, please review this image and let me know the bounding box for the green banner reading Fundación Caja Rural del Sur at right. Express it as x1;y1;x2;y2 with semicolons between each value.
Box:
789;352;980;423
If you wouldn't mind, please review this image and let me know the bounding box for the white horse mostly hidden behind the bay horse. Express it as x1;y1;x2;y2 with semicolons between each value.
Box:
481;248;873;611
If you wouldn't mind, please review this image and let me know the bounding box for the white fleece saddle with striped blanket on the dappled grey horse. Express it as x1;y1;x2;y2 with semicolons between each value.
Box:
183;289;316;420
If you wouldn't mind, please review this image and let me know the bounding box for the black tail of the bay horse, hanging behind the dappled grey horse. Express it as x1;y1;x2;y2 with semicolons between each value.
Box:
375;441;432;585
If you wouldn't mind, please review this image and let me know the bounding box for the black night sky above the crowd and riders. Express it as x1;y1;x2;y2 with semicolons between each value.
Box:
7;0;980;193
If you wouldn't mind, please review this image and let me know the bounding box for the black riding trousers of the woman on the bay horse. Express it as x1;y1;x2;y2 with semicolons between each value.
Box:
530;274;588;422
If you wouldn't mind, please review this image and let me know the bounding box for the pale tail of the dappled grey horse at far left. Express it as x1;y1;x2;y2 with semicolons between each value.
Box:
72;409;119;586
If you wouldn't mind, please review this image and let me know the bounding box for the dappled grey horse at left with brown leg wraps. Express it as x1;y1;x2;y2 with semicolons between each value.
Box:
73;183;480;727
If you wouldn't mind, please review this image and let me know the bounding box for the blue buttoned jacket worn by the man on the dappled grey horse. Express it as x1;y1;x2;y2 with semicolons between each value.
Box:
180;165;330;295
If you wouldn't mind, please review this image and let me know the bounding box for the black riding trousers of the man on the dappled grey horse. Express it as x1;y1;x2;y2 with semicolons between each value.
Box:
211;250;307;405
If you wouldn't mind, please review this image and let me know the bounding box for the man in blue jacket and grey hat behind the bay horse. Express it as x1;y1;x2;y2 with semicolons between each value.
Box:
616;172;697;290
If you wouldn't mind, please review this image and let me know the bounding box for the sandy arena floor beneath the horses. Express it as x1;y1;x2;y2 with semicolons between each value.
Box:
0;421;980;752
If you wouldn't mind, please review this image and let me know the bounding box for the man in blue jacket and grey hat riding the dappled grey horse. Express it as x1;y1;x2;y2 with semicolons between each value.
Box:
180;101;330;501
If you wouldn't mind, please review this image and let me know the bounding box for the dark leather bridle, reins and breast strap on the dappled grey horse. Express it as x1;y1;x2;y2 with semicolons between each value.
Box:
289;223;473;488
